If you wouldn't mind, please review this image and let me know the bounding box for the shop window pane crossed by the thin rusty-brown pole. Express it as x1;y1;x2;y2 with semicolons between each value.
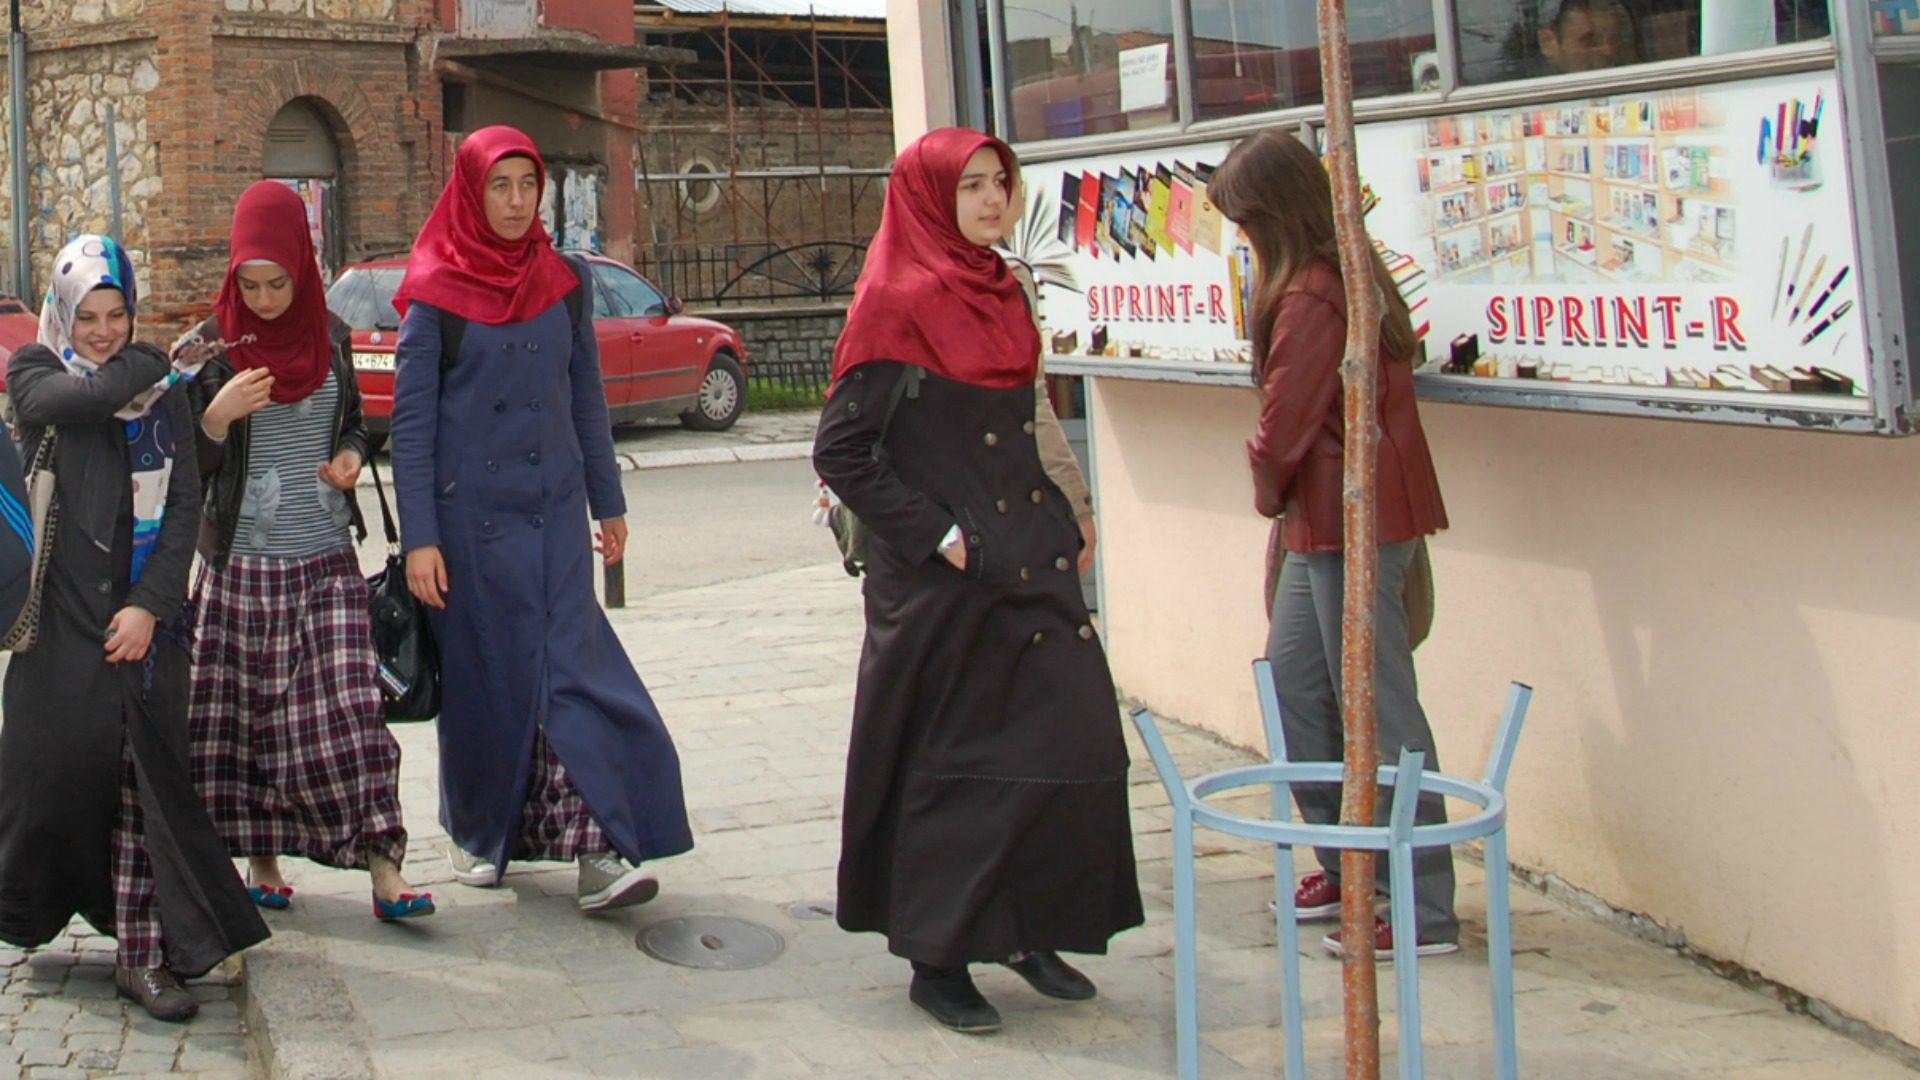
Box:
1188;0;1440;119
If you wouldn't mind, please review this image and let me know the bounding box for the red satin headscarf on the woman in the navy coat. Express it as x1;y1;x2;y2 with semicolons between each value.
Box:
394;125;580;327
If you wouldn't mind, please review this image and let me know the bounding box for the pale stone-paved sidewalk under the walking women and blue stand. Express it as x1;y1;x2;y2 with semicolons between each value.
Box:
0;565;1912;1080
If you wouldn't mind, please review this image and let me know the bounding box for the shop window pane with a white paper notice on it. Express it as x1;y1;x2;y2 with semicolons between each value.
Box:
1004;0;1179;142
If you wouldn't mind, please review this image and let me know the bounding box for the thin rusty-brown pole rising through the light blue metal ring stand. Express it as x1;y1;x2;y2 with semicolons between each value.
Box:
1319;0;1390;1080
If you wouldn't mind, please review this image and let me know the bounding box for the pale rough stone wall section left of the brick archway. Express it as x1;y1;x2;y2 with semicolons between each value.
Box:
0;40;161;302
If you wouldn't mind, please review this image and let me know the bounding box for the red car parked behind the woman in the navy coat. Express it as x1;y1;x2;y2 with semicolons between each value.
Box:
326;252;747;438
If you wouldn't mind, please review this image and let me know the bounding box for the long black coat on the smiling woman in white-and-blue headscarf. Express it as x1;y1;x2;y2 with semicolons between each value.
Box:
0;344;267;976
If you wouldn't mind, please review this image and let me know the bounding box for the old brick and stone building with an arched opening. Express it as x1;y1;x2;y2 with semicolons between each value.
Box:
0;0;685;331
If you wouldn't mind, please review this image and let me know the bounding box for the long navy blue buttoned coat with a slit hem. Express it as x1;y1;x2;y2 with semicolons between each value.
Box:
392;267;693;871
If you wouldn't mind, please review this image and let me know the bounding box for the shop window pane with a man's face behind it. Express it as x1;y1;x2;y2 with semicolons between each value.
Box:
1453;0;1835;83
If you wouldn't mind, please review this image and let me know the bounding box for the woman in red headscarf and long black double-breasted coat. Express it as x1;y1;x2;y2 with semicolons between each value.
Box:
814;129;1140;1032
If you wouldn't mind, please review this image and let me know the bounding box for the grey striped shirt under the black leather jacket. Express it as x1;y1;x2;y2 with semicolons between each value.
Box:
234;371;351;559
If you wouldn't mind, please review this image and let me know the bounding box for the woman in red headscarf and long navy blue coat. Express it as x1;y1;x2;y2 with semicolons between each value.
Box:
394;127;693;911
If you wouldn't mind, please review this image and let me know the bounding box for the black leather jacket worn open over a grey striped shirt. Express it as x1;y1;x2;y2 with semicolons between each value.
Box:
186;317;372;567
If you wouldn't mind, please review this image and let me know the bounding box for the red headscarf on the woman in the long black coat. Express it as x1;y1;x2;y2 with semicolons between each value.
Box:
833;127;1041;386
